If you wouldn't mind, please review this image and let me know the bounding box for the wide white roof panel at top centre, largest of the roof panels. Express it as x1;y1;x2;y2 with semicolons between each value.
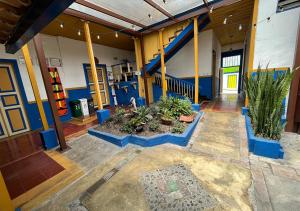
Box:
88;0;167;26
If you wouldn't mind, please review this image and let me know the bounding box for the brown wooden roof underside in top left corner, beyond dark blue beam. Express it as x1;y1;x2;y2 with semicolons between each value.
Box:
0;0;31;43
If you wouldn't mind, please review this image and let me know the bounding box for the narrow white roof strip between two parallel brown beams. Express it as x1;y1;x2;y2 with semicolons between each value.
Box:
69;3;141;30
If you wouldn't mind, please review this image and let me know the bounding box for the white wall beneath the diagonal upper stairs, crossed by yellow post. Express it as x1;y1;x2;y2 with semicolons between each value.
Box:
166;30;213;78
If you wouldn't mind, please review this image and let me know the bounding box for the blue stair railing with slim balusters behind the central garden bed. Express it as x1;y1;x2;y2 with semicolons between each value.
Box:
154;72;195;101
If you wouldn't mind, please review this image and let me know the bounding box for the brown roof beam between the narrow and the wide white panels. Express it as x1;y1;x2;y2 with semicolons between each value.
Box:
76;0;146;28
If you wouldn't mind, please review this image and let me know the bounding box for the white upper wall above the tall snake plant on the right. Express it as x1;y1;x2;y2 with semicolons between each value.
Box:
253;0;300;68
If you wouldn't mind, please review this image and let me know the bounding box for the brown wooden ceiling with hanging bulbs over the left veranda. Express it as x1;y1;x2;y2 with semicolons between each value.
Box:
42;14;134;50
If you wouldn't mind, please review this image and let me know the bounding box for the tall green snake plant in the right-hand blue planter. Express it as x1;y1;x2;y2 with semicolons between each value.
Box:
244;66;295;140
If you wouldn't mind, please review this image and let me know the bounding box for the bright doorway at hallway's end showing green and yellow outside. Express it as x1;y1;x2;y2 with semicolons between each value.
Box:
221;49;243;94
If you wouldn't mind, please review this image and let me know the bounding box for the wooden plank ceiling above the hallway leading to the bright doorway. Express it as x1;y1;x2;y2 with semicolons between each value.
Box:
207;0;254;45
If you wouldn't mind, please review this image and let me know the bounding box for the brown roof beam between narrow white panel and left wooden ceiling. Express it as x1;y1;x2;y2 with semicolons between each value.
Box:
64;8;140;36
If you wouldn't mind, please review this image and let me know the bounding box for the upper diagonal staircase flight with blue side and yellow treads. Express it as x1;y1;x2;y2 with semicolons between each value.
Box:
146;13;210;75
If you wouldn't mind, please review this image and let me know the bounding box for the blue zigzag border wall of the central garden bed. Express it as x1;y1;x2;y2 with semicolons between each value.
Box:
88;112;203;147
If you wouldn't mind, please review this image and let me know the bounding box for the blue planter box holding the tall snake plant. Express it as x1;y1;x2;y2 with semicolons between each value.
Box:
245;114;284;159
